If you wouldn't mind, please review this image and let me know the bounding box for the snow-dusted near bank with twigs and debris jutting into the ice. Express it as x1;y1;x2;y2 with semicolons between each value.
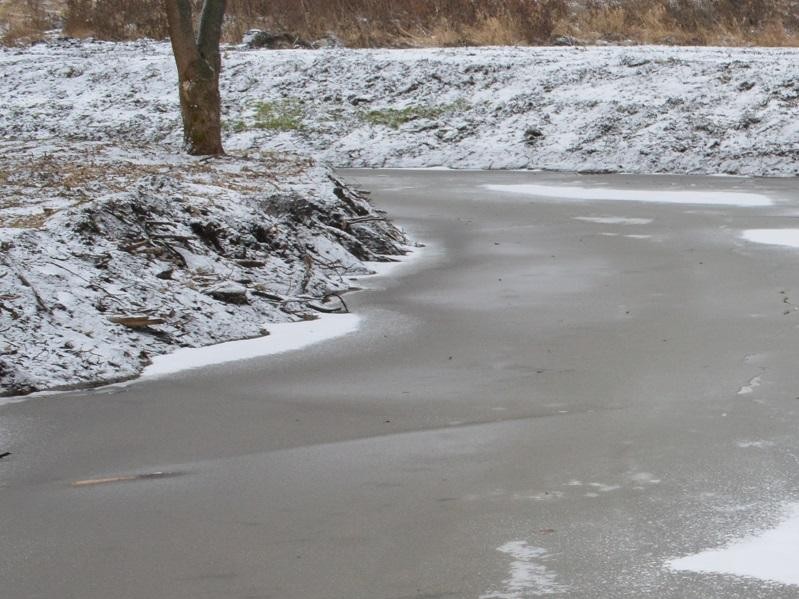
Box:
0;142;406;395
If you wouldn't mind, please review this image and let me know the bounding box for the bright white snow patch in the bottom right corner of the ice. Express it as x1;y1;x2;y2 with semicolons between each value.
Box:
667;504;799;585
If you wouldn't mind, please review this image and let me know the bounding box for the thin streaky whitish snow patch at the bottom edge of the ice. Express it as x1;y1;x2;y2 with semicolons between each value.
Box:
480;541;568;599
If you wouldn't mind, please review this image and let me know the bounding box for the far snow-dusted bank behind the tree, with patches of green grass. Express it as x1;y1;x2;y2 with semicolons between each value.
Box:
0;42;799;175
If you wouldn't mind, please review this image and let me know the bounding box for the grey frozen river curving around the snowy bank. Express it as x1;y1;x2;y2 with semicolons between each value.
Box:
0;170;799;599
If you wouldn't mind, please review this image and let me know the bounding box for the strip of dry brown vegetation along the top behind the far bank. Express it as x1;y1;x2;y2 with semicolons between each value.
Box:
0;0;799;47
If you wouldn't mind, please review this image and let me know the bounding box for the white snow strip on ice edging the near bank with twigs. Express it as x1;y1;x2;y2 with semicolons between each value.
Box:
142;314;361;377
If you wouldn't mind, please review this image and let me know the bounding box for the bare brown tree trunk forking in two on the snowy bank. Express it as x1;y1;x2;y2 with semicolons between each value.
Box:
164;0;226;156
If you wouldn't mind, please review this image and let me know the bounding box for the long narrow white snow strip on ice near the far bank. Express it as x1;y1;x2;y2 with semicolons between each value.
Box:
483;184;774;208
